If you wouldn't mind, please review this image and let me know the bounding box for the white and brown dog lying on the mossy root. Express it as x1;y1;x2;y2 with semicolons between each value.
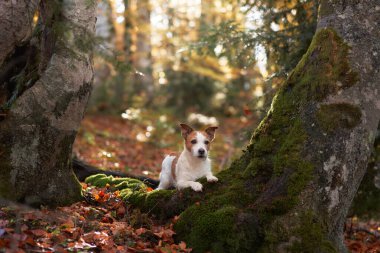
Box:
157;124;218;191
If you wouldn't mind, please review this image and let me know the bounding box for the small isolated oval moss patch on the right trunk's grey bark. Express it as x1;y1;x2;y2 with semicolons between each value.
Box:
317;103;362;132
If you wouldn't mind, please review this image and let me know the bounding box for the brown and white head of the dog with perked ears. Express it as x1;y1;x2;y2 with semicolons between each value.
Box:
180;124;218;159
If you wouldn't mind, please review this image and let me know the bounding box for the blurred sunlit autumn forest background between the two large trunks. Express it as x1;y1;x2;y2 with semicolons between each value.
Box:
75;0;318;177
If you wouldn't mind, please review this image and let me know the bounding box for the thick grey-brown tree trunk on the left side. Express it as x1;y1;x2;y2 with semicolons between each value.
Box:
0;0;96;205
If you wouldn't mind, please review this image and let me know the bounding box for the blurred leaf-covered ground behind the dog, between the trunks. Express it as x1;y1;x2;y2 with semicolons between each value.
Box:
74;115;252;179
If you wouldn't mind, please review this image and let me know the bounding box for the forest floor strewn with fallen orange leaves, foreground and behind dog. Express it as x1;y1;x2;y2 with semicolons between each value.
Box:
0;116;380;253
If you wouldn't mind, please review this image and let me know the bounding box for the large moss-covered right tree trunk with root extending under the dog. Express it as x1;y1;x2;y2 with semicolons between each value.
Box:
88;0;380;252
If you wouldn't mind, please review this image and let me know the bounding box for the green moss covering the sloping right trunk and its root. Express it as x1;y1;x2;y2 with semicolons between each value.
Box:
87;29;360;252
